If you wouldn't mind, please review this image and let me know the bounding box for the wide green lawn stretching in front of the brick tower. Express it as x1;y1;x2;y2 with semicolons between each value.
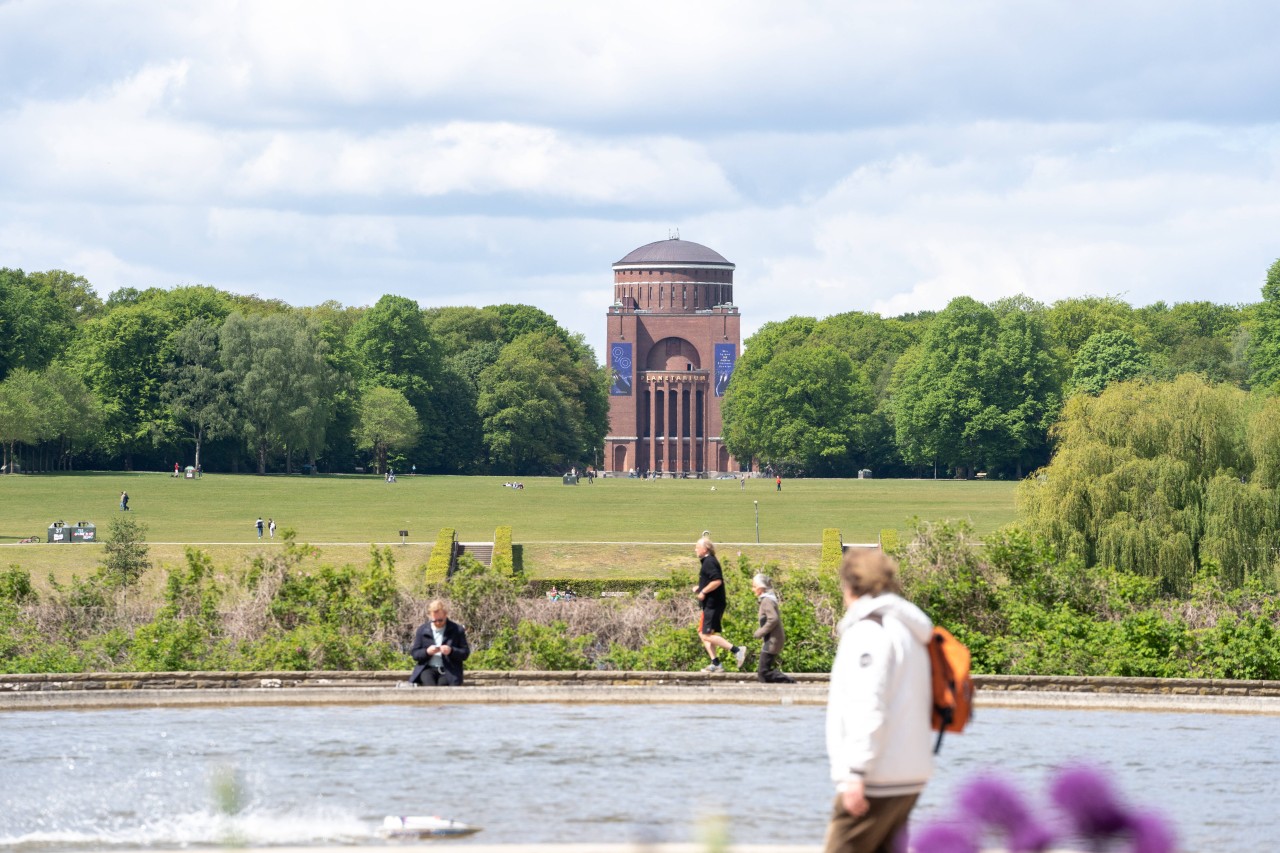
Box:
0;473;1014;578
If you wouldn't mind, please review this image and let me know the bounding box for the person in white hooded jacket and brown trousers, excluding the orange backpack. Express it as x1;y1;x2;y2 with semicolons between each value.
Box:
826;548;933;853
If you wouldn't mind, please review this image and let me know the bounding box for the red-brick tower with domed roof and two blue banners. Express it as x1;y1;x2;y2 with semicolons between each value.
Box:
604;238;741;476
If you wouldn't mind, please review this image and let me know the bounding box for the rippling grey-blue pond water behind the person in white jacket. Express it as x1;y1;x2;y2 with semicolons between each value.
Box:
0;704;1280;852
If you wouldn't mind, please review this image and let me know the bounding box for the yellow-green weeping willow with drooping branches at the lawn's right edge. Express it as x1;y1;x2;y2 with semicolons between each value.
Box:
1018;374;1280;592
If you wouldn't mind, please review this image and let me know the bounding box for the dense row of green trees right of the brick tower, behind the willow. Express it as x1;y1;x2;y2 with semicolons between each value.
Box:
724;261;1280;479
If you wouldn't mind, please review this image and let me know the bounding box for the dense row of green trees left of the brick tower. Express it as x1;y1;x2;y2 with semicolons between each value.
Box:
0;269;608;474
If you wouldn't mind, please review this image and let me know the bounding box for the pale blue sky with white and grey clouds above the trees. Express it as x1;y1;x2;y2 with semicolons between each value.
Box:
0;0;1280;353
